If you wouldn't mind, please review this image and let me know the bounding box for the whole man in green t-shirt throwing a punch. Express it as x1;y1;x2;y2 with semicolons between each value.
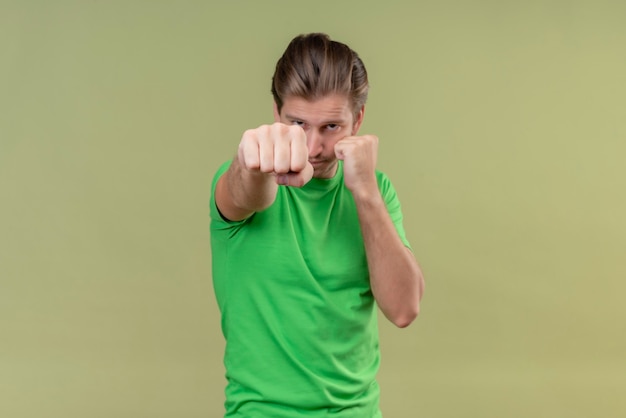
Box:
211;34;424;418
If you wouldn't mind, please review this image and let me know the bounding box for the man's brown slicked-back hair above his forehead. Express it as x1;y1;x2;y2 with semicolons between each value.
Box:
272;33;369;115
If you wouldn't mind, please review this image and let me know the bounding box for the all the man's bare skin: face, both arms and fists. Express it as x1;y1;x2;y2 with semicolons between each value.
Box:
215;94;424;328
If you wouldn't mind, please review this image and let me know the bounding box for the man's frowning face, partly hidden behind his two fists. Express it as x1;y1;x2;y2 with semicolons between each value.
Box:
274;94;365;178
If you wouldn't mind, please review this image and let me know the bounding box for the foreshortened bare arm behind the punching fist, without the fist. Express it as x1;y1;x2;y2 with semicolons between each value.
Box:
215;158;278;221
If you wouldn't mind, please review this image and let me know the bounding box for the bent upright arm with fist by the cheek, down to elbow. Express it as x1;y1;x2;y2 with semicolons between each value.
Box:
335;135;424;328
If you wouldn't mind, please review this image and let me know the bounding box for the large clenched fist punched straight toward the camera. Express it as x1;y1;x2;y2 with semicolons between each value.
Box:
237;123;313;187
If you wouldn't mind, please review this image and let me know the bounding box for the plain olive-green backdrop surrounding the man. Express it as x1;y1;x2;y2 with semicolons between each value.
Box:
0;0;626;418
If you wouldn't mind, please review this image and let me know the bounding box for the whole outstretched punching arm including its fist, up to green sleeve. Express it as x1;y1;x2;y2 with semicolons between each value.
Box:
215;123;313;221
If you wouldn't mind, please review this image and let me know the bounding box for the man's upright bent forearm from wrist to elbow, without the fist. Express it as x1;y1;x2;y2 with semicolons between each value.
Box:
355;190;424;327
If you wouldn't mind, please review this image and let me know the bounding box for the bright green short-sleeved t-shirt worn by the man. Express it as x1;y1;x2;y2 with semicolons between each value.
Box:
211;158;409;418
